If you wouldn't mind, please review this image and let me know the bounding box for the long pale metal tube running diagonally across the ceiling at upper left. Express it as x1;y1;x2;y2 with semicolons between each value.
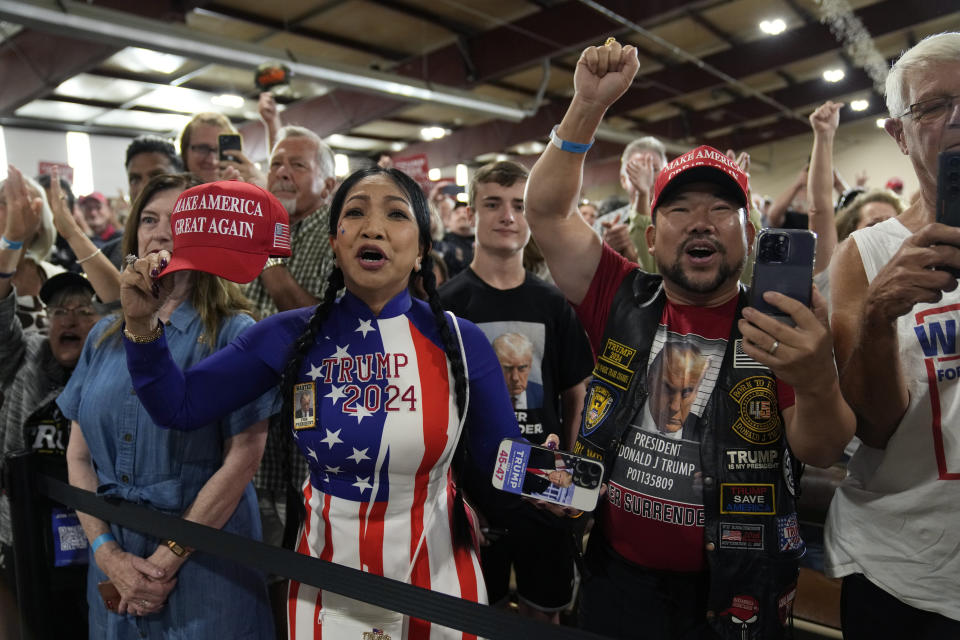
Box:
0;0;530;122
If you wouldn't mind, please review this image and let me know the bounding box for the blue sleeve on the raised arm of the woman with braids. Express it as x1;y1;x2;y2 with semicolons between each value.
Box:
123;309;312;431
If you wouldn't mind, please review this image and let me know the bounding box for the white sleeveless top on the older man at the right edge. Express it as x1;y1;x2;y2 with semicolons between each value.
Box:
825;218;960;620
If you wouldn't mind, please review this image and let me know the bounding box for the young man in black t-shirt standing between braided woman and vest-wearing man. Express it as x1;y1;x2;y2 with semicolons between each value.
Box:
440;162;593;622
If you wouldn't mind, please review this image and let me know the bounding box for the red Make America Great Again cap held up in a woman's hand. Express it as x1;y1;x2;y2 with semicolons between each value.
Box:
163;180;290;283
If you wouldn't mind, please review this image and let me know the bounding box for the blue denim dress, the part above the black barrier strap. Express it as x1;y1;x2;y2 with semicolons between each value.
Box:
57;301;275;513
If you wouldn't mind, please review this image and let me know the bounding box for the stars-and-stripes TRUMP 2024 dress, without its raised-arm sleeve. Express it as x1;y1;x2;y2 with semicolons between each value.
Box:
287;292;519;640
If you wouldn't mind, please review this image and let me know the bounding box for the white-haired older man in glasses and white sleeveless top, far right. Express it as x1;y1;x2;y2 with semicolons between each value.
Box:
826;33;960;639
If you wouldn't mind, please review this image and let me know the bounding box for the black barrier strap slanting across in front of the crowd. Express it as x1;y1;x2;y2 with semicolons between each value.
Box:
6;456;603;640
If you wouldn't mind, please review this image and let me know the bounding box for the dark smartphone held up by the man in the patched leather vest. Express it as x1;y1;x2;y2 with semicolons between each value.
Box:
750;229;817;326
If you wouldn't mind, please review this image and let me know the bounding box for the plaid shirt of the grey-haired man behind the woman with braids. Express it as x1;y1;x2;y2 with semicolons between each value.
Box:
246;205;334;492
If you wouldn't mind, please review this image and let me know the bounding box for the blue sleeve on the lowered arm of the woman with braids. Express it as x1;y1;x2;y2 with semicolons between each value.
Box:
457;318;520;474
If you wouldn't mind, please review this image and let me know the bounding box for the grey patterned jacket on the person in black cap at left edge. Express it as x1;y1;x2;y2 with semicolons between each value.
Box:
0;292;70;544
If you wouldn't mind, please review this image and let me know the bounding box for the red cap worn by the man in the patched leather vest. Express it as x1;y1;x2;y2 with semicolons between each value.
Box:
650;145;750;211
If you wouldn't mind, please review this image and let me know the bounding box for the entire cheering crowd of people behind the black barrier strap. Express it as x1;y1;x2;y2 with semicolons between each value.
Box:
0;33;960;640
